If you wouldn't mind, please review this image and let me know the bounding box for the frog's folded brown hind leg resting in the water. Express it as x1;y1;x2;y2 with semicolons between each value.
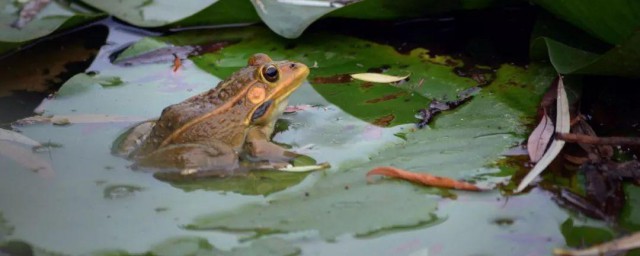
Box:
136;143;245;178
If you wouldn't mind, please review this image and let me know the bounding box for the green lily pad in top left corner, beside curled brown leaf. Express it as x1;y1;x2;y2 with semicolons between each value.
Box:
0;0;102;53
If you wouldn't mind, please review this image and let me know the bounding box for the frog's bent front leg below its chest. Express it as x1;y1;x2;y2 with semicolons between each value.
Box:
244;127;300;166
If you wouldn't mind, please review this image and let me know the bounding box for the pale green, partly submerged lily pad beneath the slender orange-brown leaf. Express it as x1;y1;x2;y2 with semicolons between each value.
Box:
188;61;552;239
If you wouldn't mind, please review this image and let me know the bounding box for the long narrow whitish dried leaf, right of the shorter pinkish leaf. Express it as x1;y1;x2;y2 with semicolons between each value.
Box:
515;77;571;193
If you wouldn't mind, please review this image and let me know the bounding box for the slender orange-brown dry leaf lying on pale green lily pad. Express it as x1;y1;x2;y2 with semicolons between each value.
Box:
367;166;481;191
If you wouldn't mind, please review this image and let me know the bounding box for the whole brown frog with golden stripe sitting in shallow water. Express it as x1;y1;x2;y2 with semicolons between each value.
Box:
116;54;316;177
